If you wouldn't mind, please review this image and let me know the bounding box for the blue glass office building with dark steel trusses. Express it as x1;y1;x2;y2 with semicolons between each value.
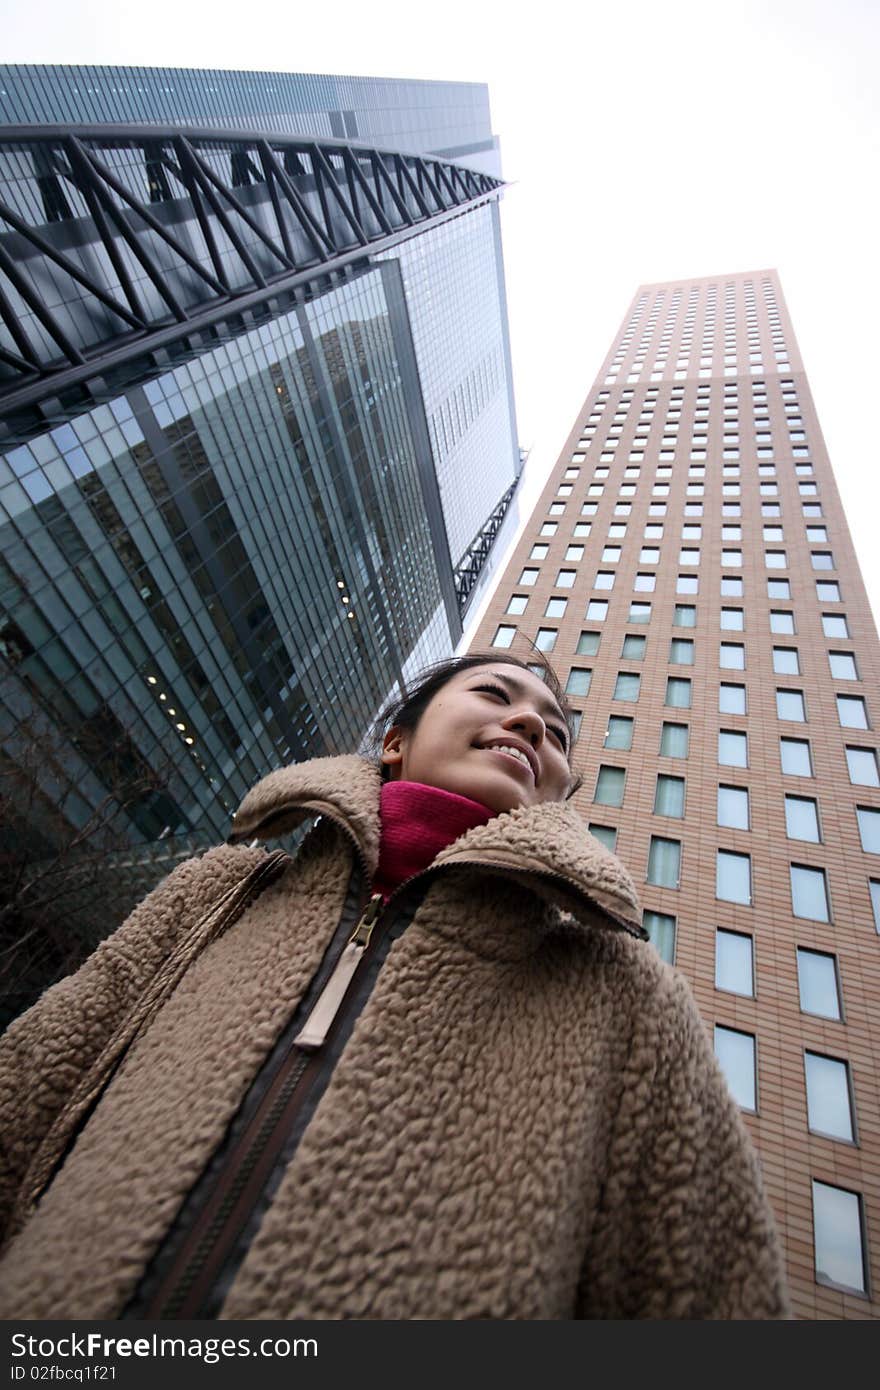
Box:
0;68;521;1011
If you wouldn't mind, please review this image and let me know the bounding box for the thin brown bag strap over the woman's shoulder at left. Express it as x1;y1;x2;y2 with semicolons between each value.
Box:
10;849;291;1234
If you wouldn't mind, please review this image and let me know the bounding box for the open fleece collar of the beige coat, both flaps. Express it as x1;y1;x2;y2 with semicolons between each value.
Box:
229;755;645;937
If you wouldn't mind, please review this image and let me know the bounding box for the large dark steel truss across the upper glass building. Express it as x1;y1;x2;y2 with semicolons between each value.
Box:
0;125;503;418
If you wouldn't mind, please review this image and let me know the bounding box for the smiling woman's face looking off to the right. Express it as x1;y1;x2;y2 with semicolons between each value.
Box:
382;662;571;813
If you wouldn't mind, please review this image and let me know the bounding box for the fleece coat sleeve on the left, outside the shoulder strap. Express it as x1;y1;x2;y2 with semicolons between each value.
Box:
0;847;263;1243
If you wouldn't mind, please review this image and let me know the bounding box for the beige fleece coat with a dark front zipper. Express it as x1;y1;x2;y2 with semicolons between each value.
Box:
0;758;787;1319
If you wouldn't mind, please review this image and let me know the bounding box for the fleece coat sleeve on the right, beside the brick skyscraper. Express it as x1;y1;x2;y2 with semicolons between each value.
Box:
577;948;790;1319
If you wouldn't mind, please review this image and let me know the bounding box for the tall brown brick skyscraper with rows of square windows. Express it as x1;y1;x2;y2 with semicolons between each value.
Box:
471;271;880;1318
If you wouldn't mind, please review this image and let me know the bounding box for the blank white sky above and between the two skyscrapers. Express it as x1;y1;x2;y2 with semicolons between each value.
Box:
6;0;880;616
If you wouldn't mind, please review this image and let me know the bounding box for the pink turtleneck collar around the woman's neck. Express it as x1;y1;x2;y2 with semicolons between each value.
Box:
373;781;495;898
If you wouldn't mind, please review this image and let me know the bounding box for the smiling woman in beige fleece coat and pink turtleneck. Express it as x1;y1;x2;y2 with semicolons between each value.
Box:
0;655;787;1319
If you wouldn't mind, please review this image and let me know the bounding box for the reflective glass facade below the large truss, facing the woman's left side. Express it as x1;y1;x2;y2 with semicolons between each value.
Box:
0;265;455;840
